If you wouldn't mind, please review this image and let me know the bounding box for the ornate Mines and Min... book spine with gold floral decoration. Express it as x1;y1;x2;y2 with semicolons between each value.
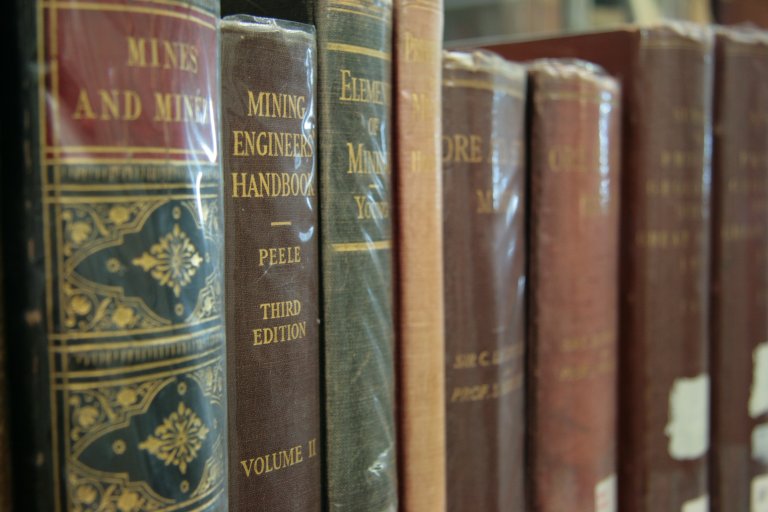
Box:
9;0;227;512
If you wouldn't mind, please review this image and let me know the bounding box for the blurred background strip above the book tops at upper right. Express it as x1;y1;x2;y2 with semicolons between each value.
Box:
445;0;768;42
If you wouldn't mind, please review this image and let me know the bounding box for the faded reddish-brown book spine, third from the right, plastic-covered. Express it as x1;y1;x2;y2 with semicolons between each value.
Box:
528;60;621;512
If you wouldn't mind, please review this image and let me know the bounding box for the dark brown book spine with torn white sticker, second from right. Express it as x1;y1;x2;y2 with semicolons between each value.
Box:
619;24;713;512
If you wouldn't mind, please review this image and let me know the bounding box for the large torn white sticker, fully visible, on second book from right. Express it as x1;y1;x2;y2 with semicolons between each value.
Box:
664;374;709;460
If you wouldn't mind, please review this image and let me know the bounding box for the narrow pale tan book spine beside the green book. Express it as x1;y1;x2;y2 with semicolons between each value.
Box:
394;0;446;511
